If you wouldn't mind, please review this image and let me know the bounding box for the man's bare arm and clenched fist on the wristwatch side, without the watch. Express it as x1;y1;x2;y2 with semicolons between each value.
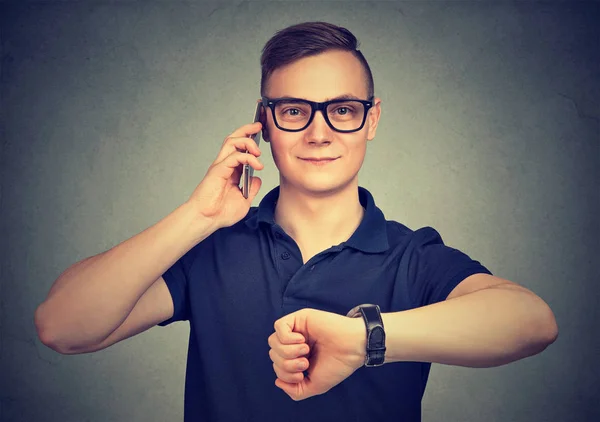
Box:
268;275;558;400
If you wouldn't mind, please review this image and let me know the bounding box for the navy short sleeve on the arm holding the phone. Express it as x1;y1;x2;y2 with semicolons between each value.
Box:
158;239;207;327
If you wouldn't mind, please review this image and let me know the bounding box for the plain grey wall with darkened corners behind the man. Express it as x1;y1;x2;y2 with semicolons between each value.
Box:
0;1;600;422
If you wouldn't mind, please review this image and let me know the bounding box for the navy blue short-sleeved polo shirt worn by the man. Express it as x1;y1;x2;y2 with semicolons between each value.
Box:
159;187;491;422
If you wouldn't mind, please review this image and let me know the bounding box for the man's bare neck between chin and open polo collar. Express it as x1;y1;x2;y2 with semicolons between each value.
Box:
275;181;364;247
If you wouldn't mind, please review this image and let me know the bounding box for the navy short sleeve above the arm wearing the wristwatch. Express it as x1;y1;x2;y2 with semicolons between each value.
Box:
408;227;492;307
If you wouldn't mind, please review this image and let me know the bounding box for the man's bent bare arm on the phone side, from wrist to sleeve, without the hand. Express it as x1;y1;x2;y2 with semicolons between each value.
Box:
34;202;212;354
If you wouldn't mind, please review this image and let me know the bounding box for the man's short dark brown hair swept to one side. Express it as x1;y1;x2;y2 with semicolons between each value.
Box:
260;22;374;98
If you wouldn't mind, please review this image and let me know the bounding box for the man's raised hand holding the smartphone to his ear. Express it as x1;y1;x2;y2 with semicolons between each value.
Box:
187;122;264;230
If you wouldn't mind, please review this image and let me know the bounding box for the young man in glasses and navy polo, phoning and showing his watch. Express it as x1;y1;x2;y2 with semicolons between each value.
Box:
36;22;557;422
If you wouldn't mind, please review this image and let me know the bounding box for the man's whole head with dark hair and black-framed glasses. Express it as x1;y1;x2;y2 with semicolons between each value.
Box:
261;22;380;192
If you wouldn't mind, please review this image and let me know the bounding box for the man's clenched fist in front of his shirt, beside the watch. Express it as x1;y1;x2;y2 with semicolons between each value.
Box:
269;309;366;400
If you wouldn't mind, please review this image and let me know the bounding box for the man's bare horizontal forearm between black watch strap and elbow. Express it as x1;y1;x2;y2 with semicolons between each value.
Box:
382;285;558;368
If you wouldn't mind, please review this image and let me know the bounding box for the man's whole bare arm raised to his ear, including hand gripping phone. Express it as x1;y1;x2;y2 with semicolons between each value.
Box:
34;122;263;353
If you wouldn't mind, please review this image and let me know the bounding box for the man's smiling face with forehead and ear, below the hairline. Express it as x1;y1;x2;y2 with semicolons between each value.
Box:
265;51;381;193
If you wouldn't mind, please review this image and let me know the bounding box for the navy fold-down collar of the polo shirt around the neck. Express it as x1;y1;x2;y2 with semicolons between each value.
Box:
246;186;390;253
